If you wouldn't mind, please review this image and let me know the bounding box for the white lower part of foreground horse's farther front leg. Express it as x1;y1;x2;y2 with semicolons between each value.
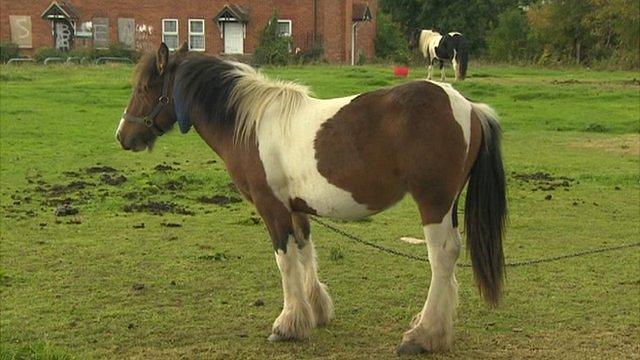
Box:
300;237;333;326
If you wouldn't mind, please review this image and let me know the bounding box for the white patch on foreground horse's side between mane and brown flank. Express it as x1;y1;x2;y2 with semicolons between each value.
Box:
256;95;374;219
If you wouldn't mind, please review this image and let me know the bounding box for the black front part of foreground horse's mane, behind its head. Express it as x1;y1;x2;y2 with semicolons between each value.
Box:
173;56;238;133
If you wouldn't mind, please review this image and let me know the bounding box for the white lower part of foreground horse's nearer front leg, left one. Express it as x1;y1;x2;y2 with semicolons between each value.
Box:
269;236;316;341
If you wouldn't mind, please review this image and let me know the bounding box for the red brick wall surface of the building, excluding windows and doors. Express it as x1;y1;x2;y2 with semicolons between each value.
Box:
0;0;377;62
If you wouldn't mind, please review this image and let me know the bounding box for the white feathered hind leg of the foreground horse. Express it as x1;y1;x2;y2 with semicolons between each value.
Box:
397;205;461;354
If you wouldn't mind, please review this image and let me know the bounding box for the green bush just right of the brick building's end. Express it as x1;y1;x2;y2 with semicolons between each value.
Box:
375;13;410;64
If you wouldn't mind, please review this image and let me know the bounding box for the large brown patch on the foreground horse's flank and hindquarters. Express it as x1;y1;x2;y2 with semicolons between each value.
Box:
315;81;470;224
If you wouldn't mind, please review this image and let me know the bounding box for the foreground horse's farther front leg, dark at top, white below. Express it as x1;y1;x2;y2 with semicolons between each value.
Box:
291;213;333;326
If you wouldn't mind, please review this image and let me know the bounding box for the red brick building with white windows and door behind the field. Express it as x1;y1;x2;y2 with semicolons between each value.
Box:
0;0;377;63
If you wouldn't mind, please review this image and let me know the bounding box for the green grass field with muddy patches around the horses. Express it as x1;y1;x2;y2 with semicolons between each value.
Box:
0;66;640;359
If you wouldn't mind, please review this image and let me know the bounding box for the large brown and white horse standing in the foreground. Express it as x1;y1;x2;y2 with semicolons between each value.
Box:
116;44;506;353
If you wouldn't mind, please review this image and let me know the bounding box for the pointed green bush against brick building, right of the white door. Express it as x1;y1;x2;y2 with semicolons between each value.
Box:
253;9;293;65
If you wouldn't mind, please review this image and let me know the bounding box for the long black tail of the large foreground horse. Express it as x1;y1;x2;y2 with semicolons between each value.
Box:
464;104;507;305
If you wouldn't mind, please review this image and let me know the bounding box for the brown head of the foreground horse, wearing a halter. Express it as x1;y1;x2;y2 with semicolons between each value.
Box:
116;43;188;151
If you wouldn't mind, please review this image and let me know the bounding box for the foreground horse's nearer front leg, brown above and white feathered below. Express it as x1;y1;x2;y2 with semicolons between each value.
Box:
256;198;316;341
